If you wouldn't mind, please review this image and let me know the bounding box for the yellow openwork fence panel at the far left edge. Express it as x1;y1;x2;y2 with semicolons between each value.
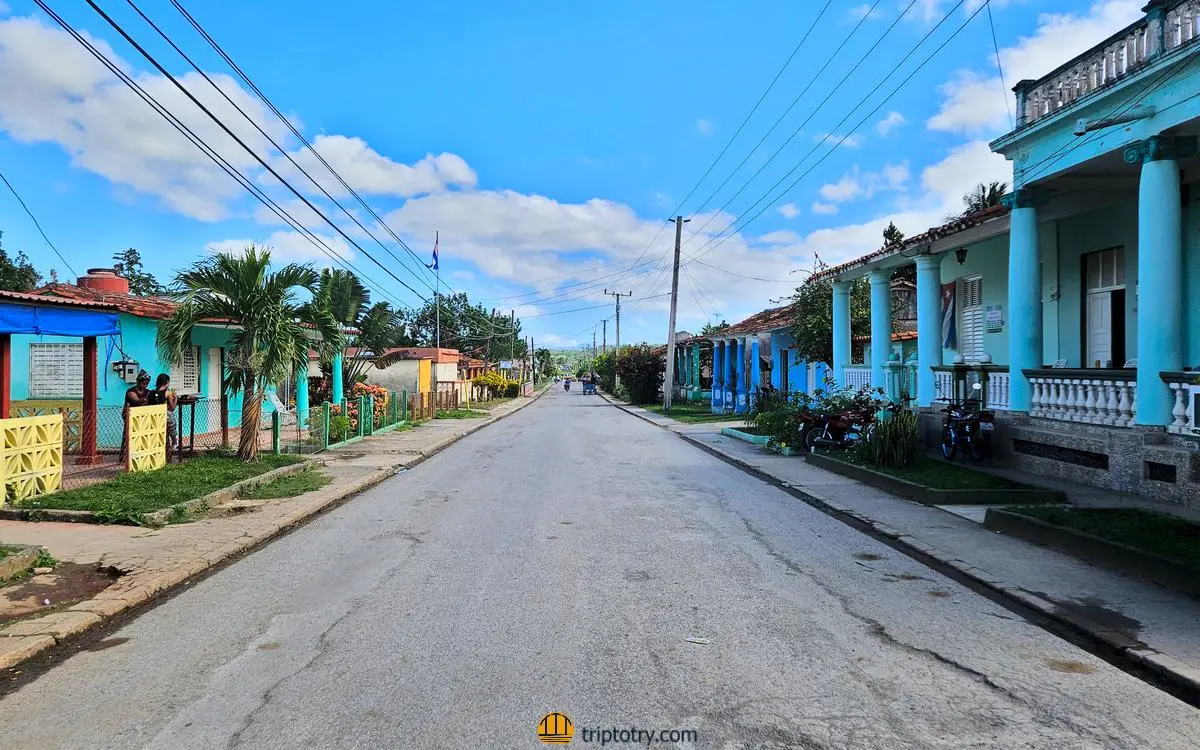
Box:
0;414;62;504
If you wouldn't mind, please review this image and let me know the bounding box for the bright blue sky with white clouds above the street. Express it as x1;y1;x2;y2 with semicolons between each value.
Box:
0;0;1144;346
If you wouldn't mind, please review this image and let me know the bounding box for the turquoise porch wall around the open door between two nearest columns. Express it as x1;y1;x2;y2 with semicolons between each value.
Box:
1056;198;1137;367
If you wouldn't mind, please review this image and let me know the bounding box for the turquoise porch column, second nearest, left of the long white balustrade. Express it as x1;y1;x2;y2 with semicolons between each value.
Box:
1006;188;1042;412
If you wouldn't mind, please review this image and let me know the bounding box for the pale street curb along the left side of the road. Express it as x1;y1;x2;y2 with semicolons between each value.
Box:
0;389;546;670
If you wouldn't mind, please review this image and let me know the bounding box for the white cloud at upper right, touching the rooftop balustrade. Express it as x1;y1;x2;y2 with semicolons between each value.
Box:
928;0;1145;133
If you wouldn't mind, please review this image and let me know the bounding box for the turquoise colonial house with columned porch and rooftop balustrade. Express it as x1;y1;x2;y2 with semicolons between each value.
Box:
822;0;1200;508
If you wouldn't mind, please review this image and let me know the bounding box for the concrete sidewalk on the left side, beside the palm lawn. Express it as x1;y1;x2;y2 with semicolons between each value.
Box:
0;390;545;668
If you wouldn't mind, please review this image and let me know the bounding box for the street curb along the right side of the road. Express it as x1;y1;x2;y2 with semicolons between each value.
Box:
606;398;1200;707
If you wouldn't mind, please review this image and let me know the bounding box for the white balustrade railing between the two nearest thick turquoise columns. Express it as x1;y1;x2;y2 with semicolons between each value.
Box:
1025;370;1138;427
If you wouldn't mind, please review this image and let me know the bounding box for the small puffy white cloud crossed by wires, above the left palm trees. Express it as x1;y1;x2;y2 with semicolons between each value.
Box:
275;136;478;198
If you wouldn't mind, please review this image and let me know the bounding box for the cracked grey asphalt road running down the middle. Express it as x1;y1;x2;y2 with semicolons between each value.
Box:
0;390;1200;750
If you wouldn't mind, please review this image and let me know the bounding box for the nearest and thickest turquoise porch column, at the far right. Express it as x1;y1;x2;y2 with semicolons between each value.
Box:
1126;136;1196;426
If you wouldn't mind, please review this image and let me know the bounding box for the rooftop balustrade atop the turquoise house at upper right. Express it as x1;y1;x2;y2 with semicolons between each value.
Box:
1016;0;1200;125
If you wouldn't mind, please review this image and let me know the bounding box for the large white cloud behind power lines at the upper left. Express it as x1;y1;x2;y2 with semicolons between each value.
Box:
0;17;295;221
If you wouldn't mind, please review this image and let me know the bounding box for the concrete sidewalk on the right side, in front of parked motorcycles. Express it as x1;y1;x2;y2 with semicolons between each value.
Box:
617;404;1200;692
